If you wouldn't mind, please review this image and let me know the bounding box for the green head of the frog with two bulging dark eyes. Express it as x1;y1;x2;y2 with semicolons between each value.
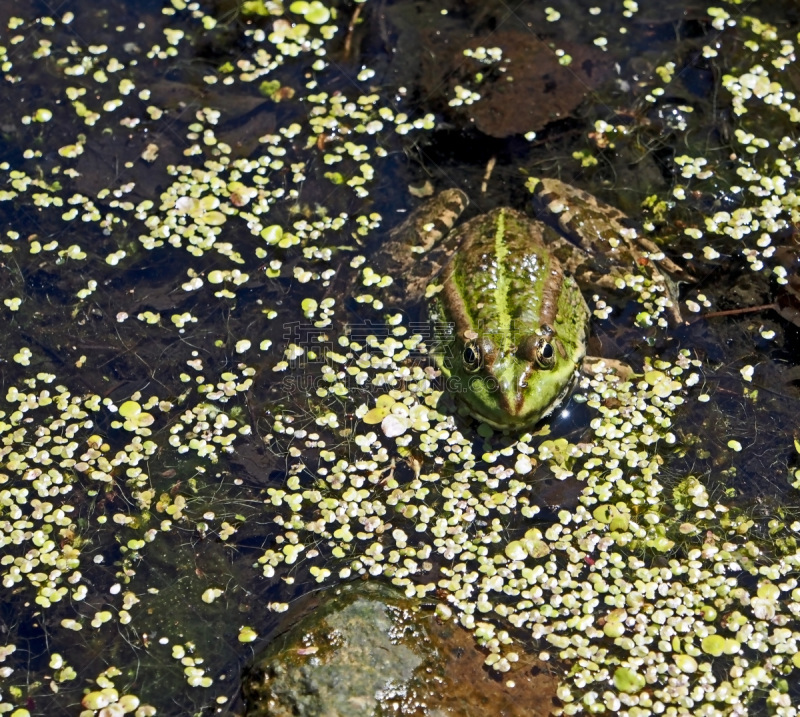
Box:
439;324;585;429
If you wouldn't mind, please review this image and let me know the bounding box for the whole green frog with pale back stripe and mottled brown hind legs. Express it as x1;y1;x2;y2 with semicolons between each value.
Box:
372;179;680;430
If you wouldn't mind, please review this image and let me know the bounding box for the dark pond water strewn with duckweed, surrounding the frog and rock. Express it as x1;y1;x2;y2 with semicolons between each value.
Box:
0;0;800;717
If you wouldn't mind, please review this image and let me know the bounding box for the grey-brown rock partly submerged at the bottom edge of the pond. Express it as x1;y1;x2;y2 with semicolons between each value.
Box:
243;582;557;717
